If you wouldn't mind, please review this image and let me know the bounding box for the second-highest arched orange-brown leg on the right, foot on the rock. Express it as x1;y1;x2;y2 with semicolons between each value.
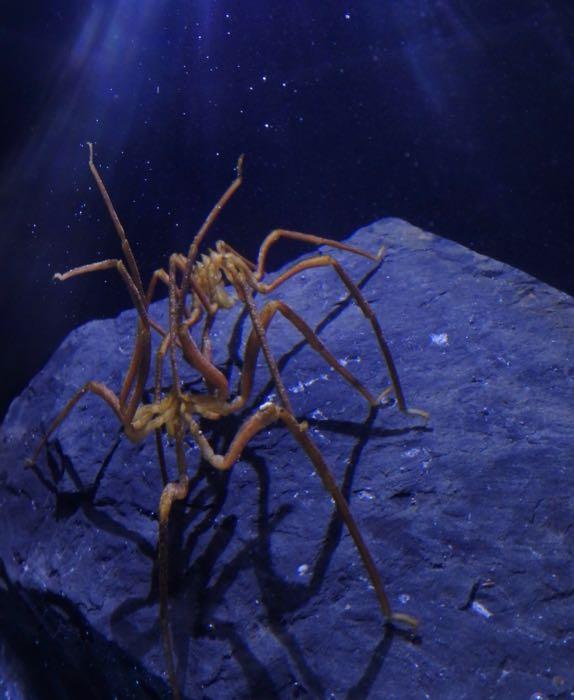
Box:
253;255;429;421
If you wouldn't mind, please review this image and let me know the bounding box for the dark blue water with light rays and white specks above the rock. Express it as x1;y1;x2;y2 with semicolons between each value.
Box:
0;0;574;422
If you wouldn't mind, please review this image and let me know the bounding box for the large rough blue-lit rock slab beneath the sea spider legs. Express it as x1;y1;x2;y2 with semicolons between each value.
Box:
0;220;574;700
